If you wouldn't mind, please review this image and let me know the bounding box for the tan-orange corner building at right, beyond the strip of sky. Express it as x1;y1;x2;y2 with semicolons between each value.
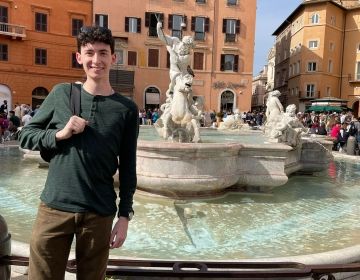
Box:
273;0;360;115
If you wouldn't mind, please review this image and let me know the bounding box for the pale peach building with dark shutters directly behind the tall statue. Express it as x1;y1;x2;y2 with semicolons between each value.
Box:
93;0;256;114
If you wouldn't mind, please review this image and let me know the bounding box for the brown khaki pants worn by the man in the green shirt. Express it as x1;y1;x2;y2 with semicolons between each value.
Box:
29;203;114;280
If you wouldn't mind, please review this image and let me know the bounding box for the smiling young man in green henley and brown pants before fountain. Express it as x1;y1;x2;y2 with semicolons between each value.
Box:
20;27;139;280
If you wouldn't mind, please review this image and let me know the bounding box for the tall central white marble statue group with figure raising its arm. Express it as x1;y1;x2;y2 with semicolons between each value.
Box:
155;22;202;143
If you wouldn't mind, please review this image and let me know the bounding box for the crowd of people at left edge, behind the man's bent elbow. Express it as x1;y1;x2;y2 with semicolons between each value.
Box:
0;100;40;143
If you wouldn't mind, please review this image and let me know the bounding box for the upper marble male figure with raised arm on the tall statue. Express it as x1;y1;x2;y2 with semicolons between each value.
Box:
156;21;195;98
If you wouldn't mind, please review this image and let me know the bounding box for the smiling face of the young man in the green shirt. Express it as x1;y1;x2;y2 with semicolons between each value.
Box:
76;42;116;80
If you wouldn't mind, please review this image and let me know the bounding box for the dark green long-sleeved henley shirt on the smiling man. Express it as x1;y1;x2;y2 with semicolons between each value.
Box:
20;84;139;216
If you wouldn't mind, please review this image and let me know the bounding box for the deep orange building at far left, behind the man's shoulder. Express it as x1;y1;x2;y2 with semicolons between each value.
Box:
0;0;92;111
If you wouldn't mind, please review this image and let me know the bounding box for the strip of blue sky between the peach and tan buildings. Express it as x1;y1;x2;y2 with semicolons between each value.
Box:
253;0;302;76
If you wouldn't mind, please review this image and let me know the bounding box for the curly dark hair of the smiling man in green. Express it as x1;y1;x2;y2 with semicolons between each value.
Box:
77;26;115;54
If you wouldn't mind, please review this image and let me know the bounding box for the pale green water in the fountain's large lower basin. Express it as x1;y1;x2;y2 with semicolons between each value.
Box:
0;148;360;260
